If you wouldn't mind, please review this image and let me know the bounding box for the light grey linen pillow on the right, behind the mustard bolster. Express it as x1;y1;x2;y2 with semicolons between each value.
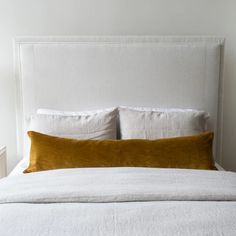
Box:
119;107;209;139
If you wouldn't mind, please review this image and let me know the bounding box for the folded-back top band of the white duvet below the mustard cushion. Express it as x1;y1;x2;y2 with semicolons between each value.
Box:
0;168;236;203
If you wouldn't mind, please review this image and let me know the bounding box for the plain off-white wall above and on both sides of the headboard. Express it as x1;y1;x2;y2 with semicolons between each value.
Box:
0;0;236;170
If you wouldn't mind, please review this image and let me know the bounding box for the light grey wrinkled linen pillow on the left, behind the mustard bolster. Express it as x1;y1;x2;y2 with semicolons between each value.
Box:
28;109;117;139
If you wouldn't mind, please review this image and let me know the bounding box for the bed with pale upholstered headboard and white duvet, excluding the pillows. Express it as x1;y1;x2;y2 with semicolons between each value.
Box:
0;36;236;236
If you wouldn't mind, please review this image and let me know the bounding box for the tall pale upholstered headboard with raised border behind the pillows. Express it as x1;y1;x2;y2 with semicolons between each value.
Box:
15;36;224;162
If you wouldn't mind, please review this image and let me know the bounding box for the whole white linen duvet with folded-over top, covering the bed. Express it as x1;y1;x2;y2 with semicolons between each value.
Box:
0;168;236;236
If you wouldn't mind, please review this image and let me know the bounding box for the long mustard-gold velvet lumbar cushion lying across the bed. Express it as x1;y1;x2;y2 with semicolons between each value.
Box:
24;131;215;173
